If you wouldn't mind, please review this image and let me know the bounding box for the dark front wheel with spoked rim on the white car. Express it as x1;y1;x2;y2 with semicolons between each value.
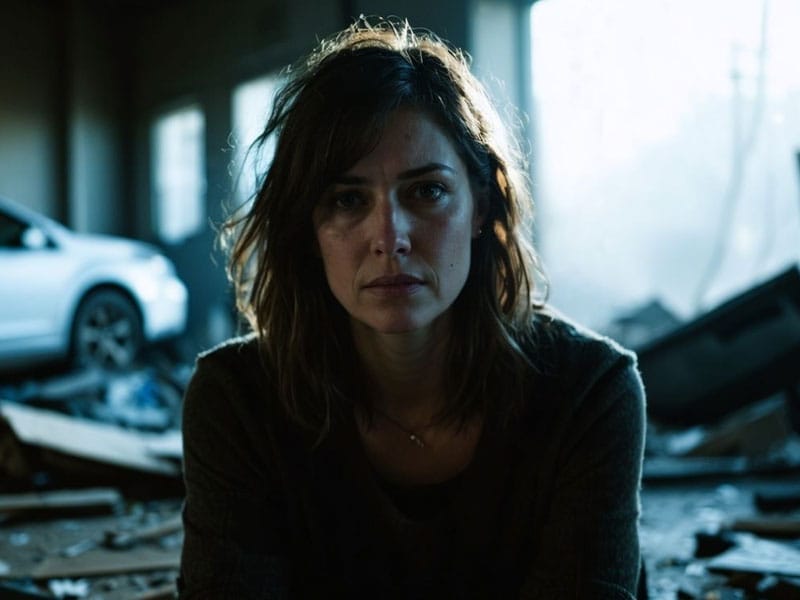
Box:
71;290;143;369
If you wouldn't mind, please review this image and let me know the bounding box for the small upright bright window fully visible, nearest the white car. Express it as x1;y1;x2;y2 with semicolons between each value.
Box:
153;106;206;243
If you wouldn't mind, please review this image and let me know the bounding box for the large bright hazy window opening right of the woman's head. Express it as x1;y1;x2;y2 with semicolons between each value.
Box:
531;0;800;327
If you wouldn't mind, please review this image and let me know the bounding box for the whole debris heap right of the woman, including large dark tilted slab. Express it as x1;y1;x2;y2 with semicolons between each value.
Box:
637;267;800;600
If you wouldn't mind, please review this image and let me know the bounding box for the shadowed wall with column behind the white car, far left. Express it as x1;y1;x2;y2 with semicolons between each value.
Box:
0;0;129;233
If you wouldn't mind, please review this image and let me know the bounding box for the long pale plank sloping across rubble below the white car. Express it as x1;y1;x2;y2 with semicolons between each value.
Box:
0;402;180;477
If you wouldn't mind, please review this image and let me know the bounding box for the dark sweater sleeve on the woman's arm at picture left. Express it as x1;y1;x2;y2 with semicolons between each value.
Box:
178;348;288;599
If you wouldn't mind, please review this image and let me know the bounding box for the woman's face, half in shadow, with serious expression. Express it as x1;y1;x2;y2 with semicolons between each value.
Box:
313;109;482;333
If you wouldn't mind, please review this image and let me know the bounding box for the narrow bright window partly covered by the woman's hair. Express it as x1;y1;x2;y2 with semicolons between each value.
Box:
232;75;278;204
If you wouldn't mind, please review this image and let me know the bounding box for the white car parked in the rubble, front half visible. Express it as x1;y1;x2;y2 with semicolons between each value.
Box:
0;198;187;370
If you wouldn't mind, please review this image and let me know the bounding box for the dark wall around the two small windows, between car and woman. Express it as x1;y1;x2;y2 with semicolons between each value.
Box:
133;0;345;350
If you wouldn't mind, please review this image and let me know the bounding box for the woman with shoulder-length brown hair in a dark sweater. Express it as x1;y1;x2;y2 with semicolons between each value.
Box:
180;17;644;600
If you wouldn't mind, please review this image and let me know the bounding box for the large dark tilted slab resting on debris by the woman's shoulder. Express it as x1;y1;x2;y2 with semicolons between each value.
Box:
635;265;800;427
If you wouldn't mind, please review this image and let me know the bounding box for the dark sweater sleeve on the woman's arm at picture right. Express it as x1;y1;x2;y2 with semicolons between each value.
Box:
520;344;645;600
